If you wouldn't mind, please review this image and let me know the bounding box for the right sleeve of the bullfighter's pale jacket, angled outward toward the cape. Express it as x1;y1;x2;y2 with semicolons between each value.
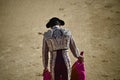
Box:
70;36;80;58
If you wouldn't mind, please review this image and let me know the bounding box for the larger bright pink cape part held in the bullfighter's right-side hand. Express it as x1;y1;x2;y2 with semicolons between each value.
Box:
71;52;86;80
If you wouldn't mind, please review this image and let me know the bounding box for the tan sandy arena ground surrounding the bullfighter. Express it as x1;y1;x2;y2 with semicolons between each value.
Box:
0;0;120;80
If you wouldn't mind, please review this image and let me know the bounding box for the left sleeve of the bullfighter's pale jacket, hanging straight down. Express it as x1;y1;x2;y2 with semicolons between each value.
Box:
42;38;49;68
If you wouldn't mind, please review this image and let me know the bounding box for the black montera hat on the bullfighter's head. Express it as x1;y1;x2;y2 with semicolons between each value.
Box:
46;17;65;28
